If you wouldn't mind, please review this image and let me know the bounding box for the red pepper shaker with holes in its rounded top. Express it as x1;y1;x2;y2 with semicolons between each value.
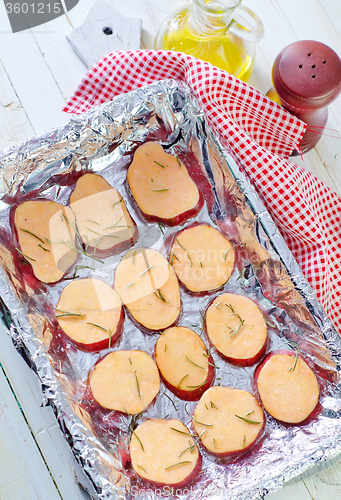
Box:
267;40;341;156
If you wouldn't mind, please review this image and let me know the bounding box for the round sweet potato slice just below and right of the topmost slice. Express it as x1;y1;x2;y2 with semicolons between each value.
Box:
169;224;234;292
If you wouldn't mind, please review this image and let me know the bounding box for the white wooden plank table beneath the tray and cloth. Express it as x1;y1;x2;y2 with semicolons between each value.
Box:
0;0;341;500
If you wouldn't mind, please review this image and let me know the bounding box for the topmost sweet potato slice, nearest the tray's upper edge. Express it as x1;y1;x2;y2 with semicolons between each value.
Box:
127;142;204;226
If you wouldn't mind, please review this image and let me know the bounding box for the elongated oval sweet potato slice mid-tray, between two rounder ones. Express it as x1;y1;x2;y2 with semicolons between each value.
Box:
115;248;181;330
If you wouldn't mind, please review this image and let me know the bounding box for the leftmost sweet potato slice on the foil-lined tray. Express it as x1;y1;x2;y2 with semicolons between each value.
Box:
14;200;77;283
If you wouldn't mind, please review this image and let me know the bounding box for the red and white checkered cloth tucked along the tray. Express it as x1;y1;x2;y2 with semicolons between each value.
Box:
64;50;341;333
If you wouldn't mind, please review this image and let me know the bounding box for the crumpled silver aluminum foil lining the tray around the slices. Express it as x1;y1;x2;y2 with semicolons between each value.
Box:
0;80;341;500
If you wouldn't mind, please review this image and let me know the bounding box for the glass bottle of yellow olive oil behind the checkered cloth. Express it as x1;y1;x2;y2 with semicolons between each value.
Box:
154;0;263;81
